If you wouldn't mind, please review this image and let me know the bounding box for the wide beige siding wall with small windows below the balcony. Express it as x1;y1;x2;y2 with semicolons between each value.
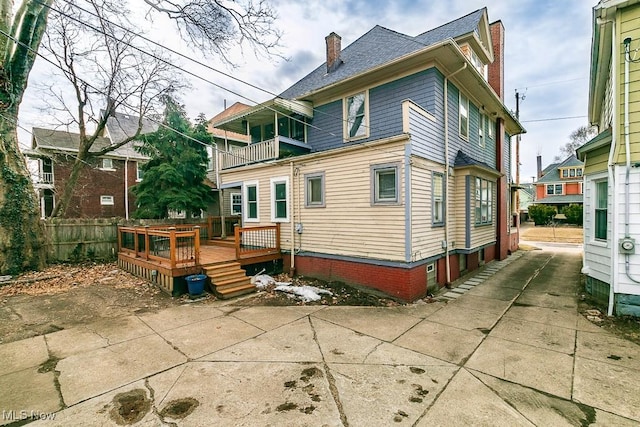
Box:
221;141;405;261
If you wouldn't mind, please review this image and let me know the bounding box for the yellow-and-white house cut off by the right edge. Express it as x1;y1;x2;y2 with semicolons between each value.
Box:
577;0;640;316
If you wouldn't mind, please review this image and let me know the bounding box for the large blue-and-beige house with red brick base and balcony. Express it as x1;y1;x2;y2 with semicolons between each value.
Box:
213;8;524;300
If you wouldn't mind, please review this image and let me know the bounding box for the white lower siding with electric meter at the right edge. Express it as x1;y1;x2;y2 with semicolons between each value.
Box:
612;166;640;295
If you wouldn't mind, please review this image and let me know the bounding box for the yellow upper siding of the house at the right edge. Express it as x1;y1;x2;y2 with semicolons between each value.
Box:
616;5;640;163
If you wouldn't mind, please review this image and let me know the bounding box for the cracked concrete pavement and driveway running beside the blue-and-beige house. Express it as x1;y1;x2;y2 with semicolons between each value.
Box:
0;248;640;426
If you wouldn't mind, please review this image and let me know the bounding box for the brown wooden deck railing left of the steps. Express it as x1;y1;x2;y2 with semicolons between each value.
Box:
118;225;201;268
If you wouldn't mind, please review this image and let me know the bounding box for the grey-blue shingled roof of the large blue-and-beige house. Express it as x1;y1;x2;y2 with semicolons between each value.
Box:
280;9;485;99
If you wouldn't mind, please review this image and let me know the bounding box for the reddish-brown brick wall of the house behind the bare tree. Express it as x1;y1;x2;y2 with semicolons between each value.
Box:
54;156;136;218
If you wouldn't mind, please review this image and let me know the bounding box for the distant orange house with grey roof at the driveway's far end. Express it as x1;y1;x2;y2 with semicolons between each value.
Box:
535;155;584;212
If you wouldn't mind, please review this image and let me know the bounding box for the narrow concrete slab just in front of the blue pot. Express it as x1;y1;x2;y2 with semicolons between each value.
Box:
138;304;224;332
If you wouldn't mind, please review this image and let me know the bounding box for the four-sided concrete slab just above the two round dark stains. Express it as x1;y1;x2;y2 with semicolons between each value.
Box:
56;335;187;405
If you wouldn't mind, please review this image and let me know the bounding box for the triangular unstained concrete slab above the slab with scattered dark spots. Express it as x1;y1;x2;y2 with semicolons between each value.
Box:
199;317;322;363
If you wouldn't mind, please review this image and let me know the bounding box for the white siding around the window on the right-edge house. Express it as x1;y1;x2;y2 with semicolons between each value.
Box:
583;172;613;283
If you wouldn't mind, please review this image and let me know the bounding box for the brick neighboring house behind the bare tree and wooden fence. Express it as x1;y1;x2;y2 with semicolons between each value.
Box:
25;113;157;218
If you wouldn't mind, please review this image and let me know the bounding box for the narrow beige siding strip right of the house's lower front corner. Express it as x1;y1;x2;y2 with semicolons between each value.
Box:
411;156;446;261
